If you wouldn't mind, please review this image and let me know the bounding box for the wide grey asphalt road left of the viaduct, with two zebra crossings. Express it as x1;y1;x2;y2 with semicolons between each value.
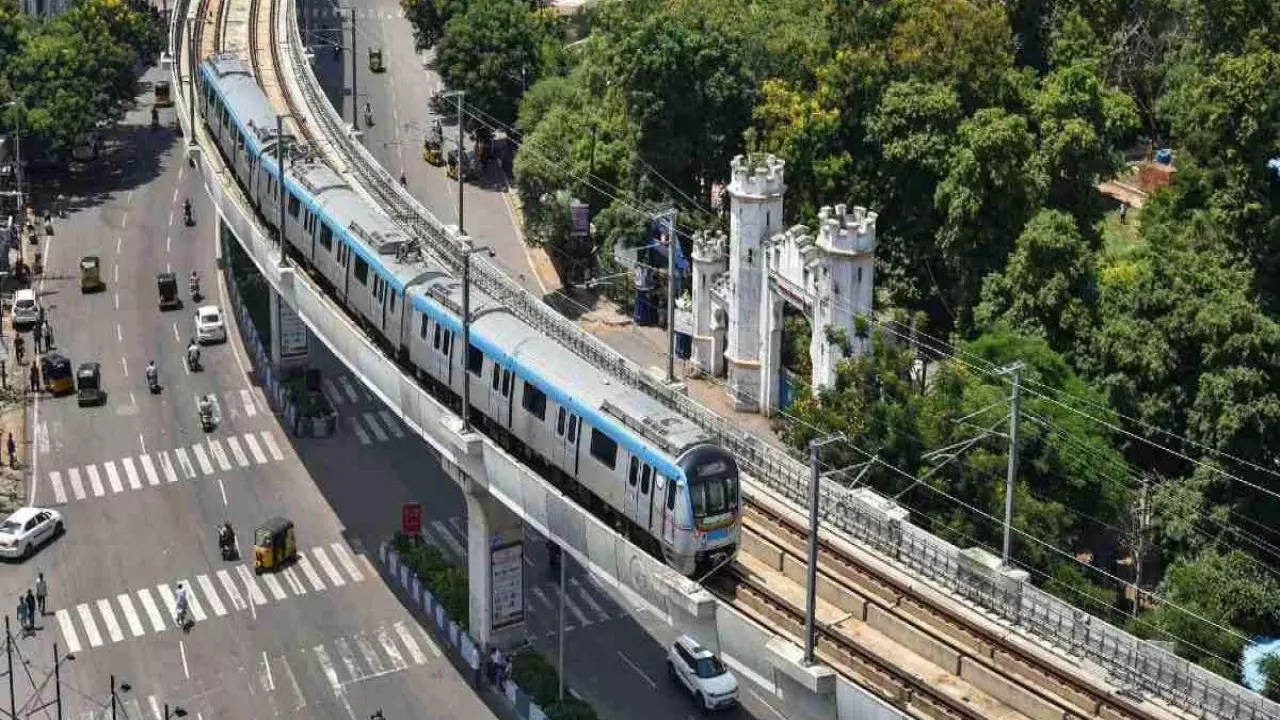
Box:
0;65;494;720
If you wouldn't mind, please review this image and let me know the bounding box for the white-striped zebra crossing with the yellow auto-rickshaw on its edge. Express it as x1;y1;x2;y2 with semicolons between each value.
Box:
54;542;374;652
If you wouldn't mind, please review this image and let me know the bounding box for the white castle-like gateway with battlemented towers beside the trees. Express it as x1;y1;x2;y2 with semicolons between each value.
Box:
691;155;876;414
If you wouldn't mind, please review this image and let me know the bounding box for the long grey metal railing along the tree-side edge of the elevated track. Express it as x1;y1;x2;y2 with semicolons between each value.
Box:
267;8;1280;720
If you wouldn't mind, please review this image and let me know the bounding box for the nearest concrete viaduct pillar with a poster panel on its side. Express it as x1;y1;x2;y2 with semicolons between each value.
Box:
462;478;525;651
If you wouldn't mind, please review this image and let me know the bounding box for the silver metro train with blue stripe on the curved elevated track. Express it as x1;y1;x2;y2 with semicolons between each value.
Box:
198;54;741;577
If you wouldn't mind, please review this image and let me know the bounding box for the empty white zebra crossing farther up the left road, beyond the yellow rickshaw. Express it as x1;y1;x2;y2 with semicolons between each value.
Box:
46;430;284;505
